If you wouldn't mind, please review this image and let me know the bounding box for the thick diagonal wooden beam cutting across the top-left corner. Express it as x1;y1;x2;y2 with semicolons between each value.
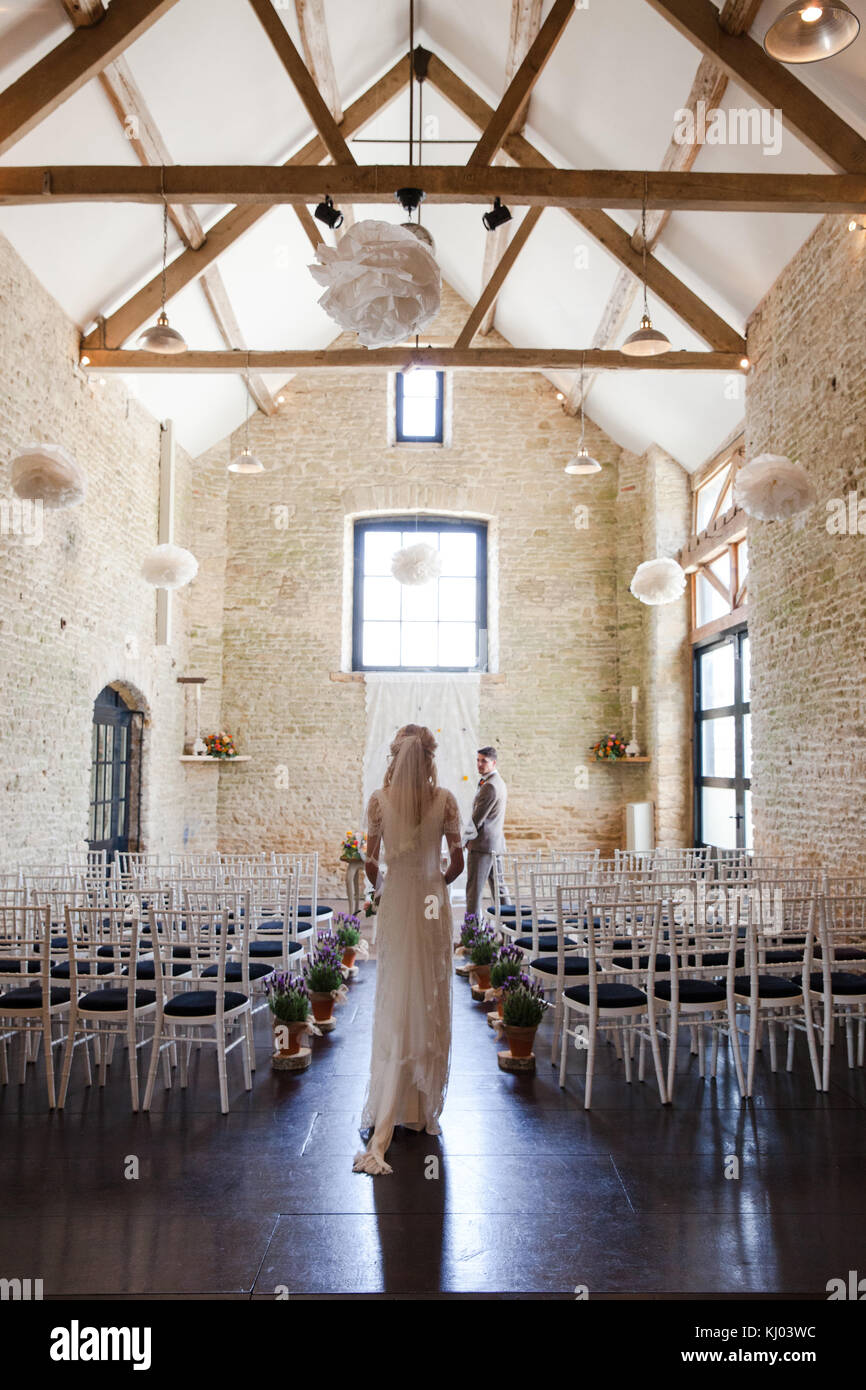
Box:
0;0;178;154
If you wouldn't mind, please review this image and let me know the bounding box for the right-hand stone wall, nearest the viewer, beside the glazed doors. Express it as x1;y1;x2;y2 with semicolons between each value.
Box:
746;217;866;872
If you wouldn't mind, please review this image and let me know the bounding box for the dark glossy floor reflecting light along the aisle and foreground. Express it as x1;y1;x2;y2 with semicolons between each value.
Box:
0;945;866;1298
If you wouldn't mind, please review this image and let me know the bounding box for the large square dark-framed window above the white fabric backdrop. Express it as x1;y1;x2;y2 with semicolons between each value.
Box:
352;517;487;671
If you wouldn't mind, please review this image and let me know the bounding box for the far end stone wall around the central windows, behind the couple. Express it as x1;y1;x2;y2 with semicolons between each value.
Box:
208;284;685;889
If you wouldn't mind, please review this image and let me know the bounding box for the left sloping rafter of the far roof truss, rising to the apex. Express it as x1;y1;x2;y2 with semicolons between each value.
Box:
82;57;409;349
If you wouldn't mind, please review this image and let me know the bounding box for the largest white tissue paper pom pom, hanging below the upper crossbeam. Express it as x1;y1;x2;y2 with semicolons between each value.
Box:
310;220;441;348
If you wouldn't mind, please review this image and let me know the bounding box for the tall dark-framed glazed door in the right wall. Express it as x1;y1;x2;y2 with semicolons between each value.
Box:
694;627;752;849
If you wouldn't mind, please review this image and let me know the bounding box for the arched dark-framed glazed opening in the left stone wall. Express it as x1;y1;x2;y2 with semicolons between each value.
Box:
89;685;142;860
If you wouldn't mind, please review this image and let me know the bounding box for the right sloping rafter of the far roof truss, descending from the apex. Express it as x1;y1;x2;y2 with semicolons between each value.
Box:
428;54;745;354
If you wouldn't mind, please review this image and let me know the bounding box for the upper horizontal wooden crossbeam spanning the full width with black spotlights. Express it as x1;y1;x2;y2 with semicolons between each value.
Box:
10;162;866;211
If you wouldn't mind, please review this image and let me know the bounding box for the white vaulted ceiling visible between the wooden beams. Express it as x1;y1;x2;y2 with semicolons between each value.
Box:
0;0;866;470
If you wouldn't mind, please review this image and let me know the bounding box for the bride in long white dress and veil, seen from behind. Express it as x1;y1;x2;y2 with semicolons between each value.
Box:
353;724;463;1175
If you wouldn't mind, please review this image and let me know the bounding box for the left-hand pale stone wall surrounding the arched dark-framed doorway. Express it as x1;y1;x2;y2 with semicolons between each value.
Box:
0;238;221;870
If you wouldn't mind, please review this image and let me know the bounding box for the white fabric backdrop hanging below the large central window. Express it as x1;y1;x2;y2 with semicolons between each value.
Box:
361;671;481;897
